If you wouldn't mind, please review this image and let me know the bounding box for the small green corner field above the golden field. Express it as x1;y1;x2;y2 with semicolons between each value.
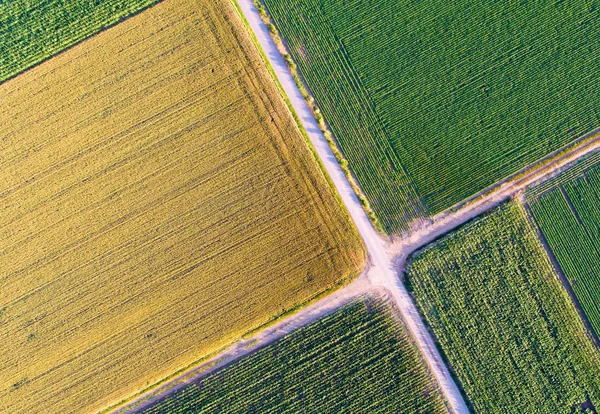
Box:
0;0;158;82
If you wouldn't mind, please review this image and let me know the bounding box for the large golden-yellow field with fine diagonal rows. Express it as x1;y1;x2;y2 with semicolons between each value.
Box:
0;0;364;413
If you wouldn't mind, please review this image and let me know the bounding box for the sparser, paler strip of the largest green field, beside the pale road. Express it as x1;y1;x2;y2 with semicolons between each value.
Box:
266;1;424;231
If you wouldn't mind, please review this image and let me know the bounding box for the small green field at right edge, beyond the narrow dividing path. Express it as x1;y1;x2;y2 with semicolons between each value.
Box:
528;155;600;335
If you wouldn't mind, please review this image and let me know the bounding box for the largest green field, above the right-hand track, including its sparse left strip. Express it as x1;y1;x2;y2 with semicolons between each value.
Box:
264;0;600;232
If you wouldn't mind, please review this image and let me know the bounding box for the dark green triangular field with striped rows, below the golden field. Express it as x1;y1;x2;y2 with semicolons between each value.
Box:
144;297;448;414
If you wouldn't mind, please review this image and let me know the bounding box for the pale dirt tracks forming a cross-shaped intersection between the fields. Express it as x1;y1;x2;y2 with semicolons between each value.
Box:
112;0;600;414
